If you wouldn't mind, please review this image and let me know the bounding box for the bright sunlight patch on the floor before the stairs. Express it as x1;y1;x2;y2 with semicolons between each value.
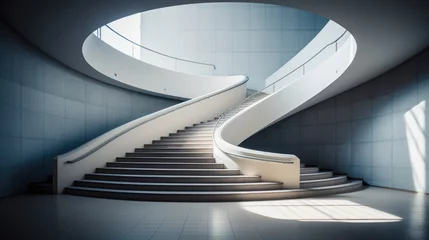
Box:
241;200;402;223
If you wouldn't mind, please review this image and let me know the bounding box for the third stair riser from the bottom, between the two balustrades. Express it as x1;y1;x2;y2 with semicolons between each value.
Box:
85;174;261;183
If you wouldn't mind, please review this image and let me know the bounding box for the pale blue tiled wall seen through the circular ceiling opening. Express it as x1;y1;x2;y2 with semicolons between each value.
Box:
141;3;328;89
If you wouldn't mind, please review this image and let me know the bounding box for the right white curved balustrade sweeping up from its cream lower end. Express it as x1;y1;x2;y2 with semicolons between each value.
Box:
214;21;356;188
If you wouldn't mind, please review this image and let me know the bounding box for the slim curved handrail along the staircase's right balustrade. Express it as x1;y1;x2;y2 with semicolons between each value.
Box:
212;30;348;162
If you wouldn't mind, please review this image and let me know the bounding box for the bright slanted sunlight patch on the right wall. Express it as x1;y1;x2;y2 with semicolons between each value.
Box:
404;101;427;192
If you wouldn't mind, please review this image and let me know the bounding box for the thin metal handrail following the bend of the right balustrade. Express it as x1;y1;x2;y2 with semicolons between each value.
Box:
212;30;348;158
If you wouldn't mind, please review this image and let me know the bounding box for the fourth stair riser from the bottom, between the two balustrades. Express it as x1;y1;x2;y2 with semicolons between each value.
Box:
95;168;240;176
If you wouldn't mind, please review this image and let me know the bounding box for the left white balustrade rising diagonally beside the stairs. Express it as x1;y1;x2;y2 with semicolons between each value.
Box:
54;76;248;193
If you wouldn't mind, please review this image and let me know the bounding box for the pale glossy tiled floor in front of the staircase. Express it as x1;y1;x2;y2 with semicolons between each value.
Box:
0;187;429;240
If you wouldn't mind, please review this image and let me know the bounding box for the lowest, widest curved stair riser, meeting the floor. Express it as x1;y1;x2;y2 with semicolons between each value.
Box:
66;184;362;202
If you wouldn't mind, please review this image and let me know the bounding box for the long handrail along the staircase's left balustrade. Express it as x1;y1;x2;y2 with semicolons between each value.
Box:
56;76;249;164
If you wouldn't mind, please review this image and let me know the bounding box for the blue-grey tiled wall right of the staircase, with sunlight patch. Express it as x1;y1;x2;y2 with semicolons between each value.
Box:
242;49;429;192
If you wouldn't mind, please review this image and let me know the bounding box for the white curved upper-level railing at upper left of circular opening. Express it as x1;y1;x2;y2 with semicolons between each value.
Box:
94;25;216;75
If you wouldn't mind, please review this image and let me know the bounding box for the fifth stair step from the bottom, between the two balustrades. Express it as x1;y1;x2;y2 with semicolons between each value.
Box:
106;162;225;169
